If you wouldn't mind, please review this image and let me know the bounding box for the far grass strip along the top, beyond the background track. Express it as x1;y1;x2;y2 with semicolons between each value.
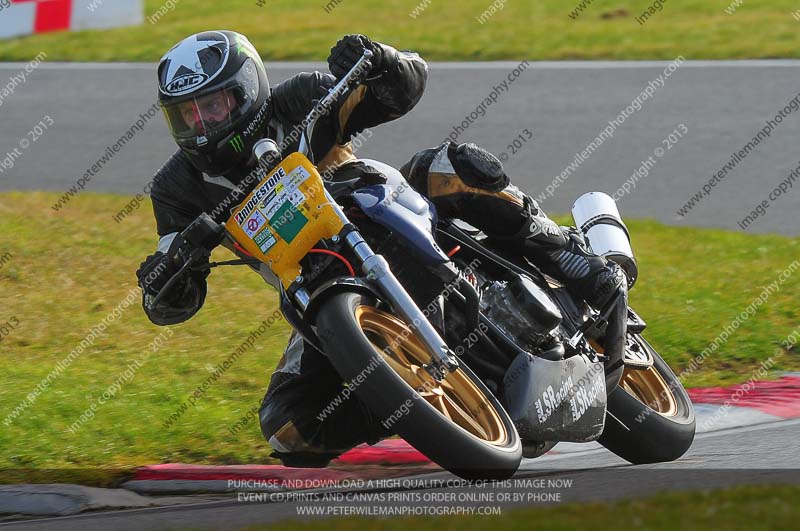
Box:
0;0;800;61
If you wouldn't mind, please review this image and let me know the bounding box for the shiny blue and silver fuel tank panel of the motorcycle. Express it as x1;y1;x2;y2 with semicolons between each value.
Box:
353;163;450;265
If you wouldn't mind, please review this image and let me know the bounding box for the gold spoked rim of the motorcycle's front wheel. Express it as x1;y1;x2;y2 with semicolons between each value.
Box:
355;306;508;446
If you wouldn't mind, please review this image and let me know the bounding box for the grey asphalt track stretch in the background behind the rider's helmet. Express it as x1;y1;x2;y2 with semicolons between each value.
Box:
0;61;800;235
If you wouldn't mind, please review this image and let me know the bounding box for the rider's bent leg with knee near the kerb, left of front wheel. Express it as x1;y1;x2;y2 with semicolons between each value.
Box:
259;334;391;467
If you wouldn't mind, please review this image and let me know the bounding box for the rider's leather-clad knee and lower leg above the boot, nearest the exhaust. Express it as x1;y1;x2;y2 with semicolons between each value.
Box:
400;141;566;247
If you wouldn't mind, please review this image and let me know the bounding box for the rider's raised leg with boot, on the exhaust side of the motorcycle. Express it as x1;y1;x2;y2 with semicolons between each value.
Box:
400;142;624;307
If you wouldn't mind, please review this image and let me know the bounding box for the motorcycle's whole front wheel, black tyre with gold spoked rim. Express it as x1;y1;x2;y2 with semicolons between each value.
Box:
316;293;522;479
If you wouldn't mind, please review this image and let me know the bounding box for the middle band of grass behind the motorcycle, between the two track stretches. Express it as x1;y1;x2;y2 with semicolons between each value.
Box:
0;193;800;476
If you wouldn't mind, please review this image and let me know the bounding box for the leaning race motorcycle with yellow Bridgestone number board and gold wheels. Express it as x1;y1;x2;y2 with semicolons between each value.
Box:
157;51;695;479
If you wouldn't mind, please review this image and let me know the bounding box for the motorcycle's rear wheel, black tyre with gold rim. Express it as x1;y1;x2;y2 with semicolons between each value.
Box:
598;334;695;464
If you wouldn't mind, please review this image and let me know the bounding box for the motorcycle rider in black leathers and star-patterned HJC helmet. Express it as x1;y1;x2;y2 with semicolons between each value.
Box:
137;31;622;466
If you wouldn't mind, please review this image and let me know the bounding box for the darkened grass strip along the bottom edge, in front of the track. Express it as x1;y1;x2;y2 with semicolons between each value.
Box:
222;485;800;531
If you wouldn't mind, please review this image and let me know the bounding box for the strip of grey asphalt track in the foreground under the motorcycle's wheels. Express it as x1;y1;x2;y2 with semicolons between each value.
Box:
0;419;800;531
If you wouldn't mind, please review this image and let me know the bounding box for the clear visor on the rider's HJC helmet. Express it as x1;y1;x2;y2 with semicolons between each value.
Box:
163;59;259;147
